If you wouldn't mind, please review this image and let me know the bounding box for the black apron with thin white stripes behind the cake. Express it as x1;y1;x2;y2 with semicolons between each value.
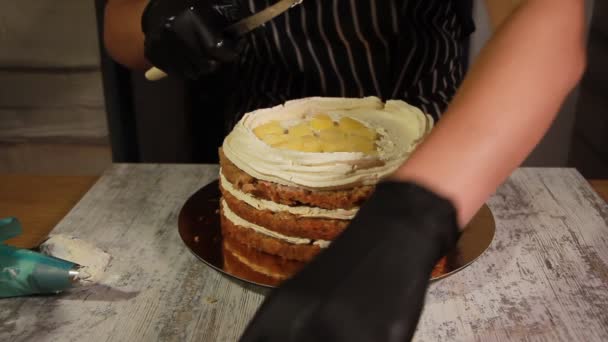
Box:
228;0;473;125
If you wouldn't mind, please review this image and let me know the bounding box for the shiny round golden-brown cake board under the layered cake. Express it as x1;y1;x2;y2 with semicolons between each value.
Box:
178;180;495;288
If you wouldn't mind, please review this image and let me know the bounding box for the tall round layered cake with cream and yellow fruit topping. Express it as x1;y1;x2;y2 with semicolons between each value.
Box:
219;97;442;285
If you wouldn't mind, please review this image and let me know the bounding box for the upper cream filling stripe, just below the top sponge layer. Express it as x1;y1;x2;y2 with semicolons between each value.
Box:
220;169;359;220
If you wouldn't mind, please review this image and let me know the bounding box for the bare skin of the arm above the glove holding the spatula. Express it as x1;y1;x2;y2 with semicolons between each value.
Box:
103;0;151;69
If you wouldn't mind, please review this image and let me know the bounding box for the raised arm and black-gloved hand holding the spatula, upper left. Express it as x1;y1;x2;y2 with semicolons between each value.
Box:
104;0;242;80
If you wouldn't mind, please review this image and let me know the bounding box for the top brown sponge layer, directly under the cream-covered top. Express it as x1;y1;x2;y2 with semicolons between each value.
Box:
219;149;374;209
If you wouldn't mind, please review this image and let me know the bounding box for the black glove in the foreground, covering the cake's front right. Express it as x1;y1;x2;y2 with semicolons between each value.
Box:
242;182;460;342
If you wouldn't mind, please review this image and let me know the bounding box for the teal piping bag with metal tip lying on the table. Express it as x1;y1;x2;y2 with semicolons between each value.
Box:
0;217;79;298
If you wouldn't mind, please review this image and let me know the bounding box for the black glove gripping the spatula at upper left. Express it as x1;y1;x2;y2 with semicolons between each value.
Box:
142;0;243;79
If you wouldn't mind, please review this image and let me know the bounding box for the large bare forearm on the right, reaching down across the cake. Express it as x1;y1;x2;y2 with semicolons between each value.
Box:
395;0;585;225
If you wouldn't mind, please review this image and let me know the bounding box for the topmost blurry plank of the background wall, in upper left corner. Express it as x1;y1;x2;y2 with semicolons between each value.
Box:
0;0;99;68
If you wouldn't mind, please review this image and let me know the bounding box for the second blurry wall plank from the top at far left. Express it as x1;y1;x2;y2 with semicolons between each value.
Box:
0;71;108;144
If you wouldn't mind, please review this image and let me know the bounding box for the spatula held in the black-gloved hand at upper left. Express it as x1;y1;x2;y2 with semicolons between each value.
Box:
146;0;303;81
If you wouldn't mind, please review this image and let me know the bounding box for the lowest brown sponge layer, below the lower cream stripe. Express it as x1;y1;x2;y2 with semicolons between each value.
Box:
220;206;321;261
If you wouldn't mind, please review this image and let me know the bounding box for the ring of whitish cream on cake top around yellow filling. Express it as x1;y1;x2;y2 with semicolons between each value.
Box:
223;97;433;190
